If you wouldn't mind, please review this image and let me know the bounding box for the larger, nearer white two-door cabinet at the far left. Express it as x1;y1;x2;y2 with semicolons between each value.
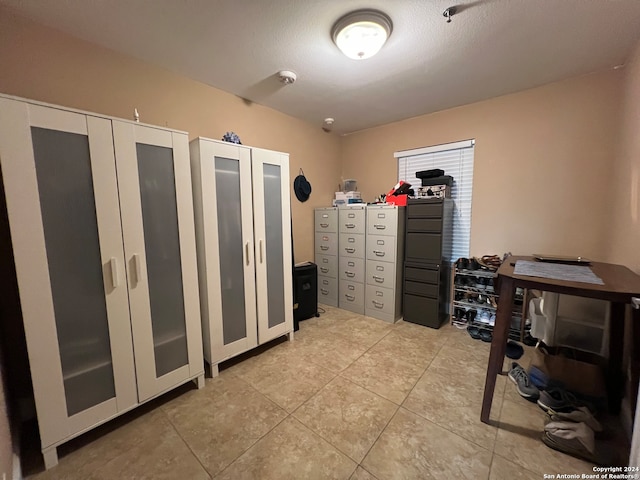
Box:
0;96;204;468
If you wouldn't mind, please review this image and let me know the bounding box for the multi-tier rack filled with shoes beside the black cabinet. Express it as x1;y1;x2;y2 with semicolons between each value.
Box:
449;260;530;341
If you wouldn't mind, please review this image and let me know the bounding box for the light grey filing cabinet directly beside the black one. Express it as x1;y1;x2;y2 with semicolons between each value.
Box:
365;205;405;323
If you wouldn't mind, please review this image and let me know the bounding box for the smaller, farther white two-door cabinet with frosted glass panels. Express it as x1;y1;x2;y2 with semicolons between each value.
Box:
190;138;293;376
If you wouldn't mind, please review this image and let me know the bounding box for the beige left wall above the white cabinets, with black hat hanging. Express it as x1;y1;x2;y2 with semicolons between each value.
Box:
0;7;341;261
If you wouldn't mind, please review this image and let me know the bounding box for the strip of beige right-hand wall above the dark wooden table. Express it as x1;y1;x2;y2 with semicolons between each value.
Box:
607;43;640;274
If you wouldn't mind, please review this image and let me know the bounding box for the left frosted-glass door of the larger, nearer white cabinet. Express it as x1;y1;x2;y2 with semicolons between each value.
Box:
0;99;137;450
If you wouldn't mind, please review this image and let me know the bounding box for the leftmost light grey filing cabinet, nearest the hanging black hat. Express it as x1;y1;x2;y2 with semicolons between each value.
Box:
315;207;338;307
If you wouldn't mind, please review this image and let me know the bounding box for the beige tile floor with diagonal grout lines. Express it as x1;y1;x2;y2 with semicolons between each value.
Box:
25;306;624;480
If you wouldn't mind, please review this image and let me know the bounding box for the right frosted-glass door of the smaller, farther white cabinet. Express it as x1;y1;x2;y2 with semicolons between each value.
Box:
251;148;293;343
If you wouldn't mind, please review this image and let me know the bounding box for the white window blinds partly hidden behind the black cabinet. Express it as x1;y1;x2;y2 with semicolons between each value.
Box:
394;140;475;262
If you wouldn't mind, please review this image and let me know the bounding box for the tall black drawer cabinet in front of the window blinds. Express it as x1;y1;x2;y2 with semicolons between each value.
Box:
403;199;453;328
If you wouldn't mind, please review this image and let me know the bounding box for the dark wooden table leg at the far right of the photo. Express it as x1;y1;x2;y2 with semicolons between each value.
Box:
606;302;625;414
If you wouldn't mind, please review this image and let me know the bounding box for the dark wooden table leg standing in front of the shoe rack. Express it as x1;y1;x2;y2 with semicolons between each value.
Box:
480;277;514;424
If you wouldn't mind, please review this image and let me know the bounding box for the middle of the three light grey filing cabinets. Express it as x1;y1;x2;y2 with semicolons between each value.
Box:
338;205;367;314
